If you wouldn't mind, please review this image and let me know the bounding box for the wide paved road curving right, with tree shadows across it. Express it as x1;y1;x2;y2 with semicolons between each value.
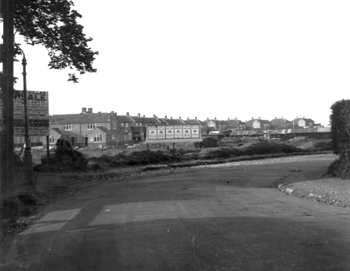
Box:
5;158;350;271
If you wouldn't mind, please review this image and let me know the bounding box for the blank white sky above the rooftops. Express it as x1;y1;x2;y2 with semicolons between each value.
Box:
8;0;350;126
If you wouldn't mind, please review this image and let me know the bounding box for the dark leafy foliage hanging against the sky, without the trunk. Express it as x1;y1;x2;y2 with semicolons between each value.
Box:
8;0;98;83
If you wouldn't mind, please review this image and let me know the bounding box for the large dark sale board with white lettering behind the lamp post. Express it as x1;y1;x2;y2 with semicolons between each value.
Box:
0;90;50;136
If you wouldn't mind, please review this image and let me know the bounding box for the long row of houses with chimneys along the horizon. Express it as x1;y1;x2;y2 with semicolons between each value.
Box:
15;107;326;148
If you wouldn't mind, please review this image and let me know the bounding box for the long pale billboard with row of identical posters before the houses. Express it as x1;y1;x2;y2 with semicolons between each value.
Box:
146;125;202;143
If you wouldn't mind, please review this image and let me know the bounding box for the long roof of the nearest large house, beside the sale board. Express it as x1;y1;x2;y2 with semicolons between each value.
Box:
50;113;111;123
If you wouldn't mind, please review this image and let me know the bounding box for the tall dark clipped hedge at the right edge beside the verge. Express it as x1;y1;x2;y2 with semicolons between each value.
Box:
330;100;350;179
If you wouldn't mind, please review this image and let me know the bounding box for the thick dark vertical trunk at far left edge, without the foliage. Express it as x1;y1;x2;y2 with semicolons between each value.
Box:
0;0;14;197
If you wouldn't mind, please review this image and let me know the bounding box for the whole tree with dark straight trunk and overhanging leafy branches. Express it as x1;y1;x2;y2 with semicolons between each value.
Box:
0;0;98;193
